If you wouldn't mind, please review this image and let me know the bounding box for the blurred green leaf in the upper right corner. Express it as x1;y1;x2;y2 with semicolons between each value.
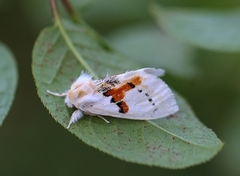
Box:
151;4;240;52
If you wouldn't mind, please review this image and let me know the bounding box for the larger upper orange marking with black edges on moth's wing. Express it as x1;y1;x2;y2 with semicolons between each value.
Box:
104;76;141;102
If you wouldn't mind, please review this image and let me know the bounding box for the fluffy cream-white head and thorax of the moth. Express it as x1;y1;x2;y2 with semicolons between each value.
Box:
65;74;94;108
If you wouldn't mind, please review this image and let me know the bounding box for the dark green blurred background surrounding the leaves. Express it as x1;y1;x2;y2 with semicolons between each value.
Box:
0;0;240;176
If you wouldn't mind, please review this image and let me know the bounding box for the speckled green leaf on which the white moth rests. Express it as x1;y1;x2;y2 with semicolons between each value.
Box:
32;18;223;168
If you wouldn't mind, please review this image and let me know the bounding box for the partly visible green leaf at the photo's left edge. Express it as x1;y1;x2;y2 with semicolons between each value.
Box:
0;43;18;125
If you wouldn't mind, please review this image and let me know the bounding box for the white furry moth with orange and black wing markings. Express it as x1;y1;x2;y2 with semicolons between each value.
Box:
47;68;179;128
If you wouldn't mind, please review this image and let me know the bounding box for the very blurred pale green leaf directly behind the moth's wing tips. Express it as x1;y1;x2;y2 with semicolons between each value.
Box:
107;23;198;78
